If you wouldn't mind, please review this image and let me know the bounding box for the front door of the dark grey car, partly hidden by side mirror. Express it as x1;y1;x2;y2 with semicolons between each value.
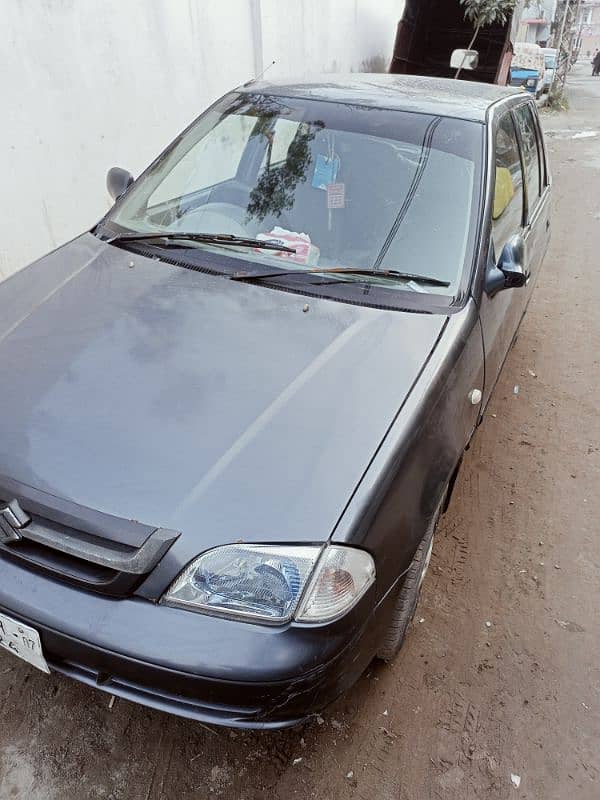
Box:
479;110;527;409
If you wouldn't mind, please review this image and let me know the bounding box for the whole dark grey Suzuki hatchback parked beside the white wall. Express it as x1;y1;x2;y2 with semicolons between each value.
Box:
0;75;550;728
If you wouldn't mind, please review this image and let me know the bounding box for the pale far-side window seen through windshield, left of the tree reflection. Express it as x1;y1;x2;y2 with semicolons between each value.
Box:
148;114;256;206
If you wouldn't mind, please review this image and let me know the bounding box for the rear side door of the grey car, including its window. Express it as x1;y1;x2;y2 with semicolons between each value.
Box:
513;103;550;300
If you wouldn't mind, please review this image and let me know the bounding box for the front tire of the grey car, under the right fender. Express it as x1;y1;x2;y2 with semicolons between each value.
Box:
377;500;446;661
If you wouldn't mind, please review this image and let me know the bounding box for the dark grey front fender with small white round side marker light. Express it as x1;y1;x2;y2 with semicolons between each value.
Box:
333;300;484;595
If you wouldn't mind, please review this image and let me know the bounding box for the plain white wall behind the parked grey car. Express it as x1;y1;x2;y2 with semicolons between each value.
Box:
0;0;404;279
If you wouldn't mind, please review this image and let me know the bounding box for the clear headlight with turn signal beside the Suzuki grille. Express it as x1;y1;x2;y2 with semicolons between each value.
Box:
163;544;375;623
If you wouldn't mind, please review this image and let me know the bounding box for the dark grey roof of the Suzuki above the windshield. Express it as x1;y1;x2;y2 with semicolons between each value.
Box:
239;73;523;122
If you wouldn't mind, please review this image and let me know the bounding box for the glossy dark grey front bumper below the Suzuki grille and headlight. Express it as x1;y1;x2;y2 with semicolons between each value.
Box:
0;561;383;729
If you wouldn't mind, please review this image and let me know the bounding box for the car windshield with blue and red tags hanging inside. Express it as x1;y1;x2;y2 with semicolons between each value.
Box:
105;93;484;295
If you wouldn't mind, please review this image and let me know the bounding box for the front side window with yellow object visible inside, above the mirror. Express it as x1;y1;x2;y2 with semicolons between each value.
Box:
492;113;523;257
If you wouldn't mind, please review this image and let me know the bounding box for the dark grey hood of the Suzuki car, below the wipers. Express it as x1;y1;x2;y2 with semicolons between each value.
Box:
0;234;446;552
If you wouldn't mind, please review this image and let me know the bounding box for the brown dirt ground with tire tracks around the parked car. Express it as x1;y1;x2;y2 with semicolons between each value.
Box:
0;65;600;800
